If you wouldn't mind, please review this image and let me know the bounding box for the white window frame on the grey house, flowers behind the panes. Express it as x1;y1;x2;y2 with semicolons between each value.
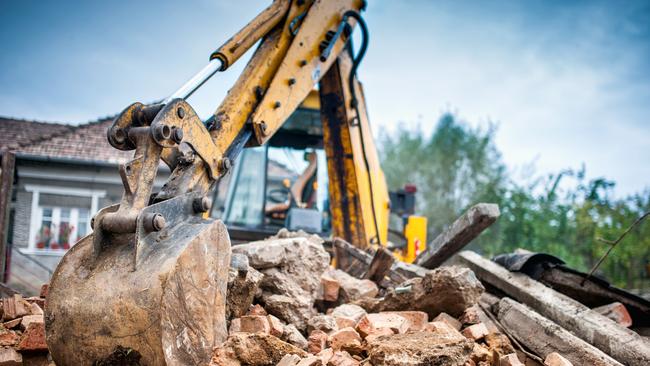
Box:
20;184;106;256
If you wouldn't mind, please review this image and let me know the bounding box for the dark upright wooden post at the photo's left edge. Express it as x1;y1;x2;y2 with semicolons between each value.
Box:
0;150;16;282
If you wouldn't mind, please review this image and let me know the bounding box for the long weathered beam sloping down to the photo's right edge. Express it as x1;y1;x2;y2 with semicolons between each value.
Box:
456;251;650;366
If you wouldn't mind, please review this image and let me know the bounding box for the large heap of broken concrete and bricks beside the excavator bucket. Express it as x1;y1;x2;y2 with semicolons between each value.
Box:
210;231;556;366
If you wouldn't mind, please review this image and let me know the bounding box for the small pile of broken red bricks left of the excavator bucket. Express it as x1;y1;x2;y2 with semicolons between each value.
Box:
0;285;51;366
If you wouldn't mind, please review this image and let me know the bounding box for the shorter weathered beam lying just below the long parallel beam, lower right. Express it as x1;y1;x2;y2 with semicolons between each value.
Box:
497;297;621;366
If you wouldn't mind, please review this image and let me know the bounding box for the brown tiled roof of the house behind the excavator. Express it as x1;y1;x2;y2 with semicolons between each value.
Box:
0;117;133;164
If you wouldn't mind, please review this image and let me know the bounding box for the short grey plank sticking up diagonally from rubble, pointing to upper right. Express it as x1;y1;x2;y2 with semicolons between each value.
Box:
415;203;501;269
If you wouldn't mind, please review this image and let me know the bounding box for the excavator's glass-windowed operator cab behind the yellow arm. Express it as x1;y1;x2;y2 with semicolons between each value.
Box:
210;90;331;243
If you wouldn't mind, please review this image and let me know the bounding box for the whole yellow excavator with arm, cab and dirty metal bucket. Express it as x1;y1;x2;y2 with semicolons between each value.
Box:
45;0;426;365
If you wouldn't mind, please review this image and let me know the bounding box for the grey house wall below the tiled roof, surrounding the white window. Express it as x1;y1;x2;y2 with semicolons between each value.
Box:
7;159;169;294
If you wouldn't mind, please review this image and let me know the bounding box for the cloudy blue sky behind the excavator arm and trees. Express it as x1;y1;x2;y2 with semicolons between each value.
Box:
0;0;650;196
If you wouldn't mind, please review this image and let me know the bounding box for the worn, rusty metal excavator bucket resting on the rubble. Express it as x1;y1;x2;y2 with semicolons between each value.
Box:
45;193;230;365
